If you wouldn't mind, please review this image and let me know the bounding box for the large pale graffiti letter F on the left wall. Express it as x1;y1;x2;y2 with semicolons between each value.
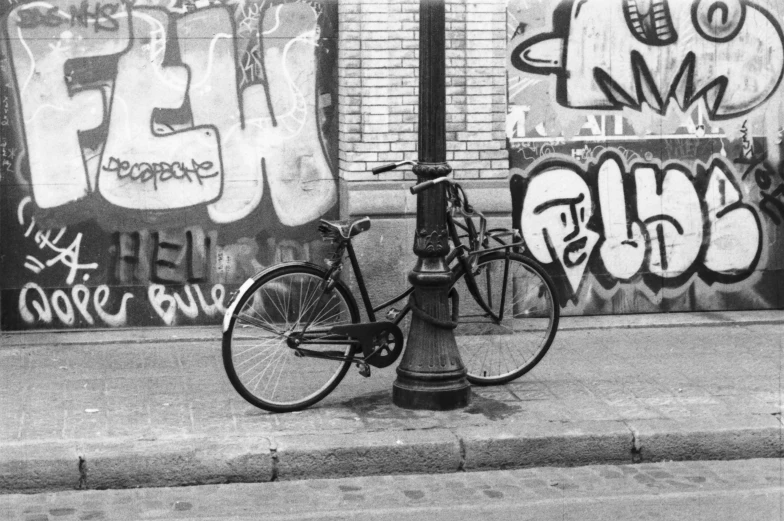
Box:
6;0;130;208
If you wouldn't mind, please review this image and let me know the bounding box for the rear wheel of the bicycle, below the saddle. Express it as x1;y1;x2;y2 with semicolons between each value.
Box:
223;263;360;412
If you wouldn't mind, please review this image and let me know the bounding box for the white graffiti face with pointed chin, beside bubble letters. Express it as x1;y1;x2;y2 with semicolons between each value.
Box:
521;167;599;293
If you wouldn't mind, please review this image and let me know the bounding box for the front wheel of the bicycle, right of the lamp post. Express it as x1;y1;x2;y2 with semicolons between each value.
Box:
454;251;559;385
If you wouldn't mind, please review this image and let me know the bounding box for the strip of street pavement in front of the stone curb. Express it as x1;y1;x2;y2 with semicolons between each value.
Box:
0;459;784;521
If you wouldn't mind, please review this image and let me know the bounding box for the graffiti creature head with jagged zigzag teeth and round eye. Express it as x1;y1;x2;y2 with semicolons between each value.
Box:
511;0;784;120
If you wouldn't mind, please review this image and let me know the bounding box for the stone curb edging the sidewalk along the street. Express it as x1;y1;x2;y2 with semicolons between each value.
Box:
0;415;784;494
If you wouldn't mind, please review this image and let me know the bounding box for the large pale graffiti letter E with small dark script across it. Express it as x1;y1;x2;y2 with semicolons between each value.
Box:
98;8;222;210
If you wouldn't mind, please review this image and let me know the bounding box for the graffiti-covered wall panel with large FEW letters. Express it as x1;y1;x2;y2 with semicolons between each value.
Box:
0;0;337;330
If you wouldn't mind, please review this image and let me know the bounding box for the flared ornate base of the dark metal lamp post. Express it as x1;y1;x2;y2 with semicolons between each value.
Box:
392;257;471;411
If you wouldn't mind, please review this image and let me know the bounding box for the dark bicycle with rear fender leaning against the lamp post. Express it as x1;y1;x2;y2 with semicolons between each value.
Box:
223;161;559;412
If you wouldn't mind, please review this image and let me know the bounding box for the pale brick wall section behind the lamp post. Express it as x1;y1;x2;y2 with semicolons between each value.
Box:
338;0;509;182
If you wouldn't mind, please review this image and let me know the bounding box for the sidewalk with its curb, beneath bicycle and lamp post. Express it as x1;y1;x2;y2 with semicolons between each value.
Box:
0;311;784;492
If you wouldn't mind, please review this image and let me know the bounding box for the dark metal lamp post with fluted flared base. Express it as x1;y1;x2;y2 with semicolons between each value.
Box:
392;0;471;410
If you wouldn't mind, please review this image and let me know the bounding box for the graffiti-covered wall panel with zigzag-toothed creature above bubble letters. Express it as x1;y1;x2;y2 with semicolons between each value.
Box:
507;0;784;314
